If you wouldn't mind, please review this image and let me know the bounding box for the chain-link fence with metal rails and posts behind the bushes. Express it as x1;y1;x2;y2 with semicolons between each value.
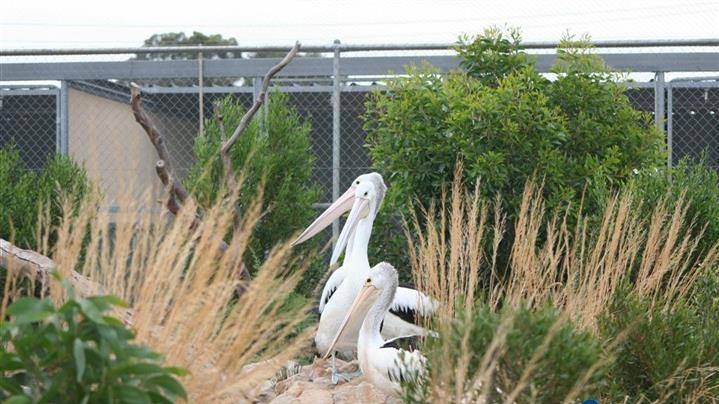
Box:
0;41;719;215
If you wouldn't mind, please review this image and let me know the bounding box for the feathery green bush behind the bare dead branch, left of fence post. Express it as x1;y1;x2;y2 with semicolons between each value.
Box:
185;93;320;284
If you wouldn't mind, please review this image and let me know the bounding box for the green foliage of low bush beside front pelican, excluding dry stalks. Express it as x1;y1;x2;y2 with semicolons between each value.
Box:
405;304;603;403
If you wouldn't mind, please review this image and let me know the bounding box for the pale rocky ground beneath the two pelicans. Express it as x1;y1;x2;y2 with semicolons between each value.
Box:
257;360;402;404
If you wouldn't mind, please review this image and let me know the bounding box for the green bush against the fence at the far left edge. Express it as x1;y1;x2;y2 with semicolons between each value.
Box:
0;145;88;249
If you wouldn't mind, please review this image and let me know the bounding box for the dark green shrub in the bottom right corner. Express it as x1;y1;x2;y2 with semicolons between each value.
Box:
600;285;719;402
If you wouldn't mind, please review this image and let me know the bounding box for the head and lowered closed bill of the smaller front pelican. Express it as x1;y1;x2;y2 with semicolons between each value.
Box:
324;262;399;358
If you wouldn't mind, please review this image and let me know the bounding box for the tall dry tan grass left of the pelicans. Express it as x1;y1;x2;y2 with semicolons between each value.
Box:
3;181;314;402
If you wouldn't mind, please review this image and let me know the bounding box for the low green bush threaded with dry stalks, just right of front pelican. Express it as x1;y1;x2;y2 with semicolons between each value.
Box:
404;303;603;403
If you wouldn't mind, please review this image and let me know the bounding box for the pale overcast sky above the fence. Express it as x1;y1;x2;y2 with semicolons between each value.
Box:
0;0;719;49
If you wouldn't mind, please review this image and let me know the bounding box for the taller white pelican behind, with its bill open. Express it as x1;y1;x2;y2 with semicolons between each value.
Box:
293;173;437;379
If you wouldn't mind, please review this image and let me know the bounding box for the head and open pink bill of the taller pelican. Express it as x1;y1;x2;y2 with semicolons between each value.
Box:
292;173;387;265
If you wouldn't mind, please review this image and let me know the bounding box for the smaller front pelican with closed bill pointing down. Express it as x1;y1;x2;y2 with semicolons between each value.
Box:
324;262;426;392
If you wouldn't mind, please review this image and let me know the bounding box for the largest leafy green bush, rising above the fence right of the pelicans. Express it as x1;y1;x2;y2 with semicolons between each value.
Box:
364;30;664;278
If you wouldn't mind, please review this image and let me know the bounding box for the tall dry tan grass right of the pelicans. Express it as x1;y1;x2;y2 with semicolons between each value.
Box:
406;167;719;403
